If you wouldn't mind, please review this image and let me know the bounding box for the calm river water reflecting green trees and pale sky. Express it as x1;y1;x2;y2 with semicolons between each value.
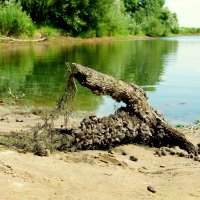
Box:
0;37;200;123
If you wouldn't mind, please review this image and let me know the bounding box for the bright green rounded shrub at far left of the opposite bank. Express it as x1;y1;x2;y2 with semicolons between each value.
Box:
0;1;35;36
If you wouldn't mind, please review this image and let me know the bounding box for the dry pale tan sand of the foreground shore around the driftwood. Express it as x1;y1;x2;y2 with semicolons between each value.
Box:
0;108;200;200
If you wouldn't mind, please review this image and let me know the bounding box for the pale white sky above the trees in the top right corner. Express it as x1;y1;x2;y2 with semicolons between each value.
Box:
165;0;200;28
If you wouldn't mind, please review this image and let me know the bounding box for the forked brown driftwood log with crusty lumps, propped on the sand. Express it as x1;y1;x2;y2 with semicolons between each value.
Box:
60;63;196;154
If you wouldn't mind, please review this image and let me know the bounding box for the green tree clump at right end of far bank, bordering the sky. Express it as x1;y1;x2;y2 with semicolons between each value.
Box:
124;0;179;36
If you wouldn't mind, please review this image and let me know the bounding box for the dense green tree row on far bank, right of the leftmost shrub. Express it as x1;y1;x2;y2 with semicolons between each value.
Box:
0;0;179;37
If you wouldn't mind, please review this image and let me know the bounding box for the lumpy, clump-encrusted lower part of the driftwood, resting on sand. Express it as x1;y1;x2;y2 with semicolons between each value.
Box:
58;108;196;153
